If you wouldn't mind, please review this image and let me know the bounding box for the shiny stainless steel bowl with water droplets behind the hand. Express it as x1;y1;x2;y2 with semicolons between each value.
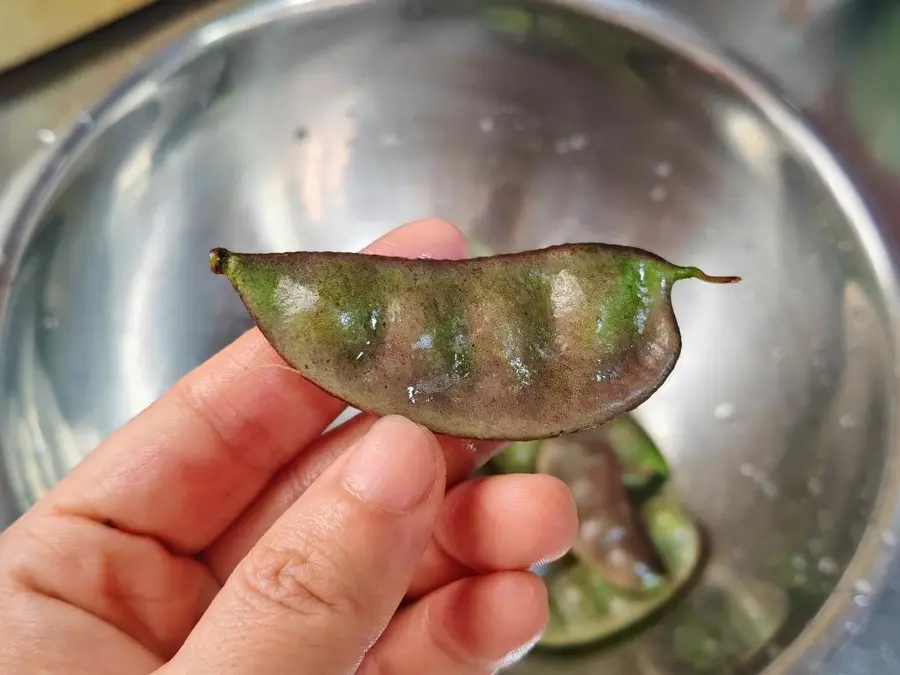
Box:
0;0;900;675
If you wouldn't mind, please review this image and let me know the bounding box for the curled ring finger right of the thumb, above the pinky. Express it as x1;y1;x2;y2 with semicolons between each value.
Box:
407;475;578;598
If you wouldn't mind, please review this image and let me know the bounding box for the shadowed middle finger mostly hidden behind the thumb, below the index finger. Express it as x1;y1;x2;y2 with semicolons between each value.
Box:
201;414;497;581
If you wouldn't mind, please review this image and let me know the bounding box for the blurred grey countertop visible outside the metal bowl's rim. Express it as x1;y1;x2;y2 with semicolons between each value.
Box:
0;0;900;675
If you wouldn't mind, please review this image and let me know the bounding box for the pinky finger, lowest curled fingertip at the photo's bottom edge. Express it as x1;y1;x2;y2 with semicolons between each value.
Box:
357;572;548;675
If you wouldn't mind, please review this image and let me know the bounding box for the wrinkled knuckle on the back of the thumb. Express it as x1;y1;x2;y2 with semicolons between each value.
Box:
240;541;361;617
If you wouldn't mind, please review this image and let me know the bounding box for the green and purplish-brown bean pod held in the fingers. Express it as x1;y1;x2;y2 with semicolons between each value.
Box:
210;244;737;440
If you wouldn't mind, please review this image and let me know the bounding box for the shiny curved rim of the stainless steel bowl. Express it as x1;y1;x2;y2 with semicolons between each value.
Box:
0;0;900;675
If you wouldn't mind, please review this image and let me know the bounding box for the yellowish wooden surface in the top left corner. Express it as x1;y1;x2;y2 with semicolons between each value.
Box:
0;0;154;72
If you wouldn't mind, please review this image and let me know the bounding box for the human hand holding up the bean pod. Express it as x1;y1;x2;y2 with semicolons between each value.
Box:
0;220;577;675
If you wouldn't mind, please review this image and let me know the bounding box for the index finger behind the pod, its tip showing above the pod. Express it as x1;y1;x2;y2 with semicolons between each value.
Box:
36;220;465;553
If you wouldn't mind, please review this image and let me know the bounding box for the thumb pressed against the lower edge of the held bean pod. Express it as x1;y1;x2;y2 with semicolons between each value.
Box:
163;417;445;675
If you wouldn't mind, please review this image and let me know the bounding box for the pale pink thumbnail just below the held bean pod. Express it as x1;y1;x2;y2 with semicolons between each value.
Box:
344;416;436;511
